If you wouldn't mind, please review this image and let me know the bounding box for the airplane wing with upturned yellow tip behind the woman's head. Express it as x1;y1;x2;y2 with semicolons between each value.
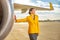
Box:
14;3;54;13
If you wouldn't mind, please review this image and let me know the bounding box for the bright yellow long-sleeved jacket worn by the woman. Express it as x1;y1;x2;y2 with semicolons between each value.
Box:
16;15;39;34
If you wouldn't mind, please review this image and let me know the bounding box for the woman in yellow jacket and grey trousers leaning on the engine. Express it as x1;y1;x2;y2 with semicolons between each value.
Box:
14;8;39;40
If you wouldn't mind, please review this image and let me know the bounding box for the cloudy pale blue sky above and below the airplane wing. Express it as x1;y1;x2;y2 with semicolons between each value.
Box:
14;0;60;20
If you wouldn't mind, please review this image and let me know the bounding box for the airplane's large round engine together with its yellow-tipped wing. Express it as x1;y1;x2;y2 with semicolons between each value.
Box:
0;0;54;40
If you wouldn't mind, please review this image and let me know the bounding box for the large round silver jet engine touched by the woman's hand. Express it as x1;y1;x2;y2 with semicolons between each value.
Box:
0;0;13;40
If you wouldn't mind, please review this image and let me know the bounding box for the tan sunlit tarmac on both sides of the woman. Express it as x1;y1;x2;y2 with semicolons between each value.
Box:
4;22;60;40
